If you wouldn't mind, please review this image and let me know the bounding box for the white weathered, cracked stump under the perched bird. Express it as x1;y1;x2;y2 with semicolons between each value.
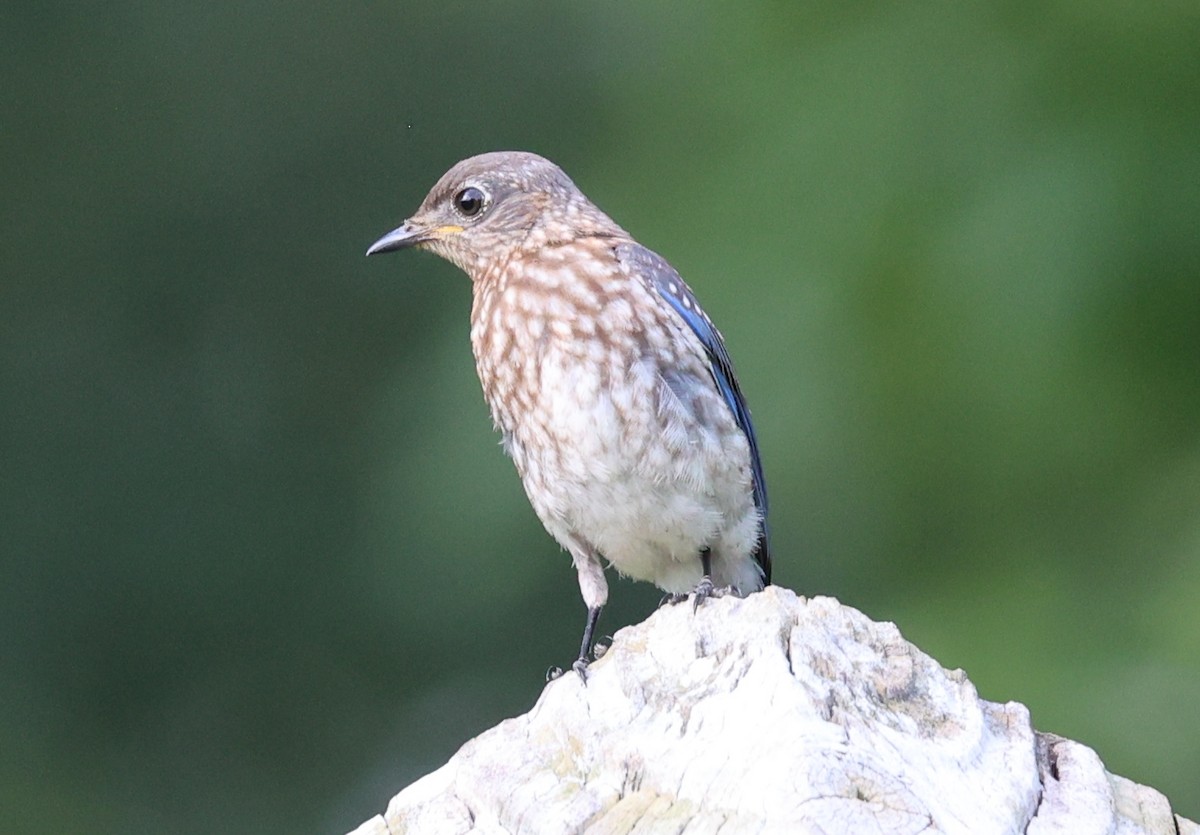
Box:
353;587;1200;835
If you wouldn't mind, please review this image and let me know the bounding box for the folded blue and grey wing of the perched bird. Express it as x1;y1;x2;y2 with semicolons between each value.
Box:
613;242;770;583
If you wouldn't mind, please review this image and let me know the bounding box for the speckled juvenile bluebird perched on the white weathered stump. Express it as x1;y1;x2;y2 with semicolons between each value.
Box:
367;152;770;675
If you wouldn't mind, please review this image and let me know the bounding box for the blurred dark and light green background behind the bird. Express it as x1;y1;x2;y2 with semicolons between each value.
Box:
0;0;1200;833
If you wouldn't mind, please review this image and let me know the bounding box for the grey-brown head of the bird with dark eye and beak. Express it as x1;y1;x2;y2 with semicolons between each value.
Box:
367;151;623;278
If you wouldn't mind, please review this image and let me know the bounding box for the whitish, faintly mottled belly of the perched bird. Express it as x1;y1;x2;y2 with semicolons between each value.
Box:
510;358;762;593
